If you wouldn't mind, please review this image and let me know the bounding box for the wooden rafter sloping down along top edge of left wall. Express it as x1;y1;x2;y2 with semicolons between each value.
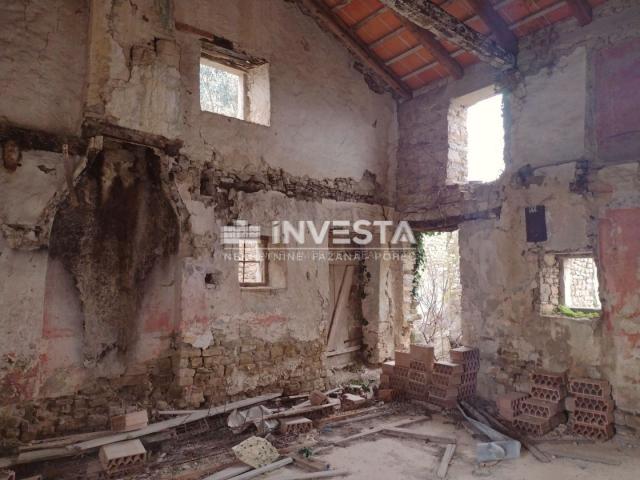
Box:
298;0;412;99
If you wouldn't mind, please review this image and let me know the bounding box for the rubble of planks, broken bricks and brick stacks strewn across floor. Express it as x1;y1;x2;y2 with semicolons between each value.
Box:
0;358;631;480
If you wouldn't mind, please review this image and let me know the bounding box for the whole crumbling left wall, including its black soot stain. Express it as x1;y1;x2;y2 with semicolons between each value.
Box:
0;0;407;446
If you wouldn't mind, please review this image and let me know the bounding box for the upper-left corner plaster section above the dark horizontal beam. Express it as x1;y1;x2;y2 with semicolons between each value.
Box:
0;0;89;134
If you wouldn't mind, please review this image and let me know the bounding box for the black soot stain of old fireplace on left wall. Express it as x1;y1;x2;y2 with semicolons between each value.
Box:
49;143;179;366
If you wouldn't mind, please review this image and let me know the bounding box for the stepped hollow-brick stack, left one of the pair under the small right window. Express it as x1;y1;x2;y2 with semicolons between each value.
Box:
513;371;566;436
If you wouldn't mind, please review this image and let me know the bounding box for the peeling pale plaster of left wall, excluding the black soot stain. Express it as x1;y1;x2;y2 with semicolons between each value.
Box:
0;0;403;432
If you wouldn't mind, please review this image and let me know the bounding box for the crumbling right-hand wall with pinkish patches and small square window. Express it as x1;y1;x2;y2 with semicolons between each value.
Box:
398;0;640;420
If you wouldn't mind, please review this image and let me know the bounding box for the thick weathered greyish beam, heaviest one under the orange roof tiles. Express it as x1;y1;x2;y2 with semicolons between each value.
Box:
380;0;516;67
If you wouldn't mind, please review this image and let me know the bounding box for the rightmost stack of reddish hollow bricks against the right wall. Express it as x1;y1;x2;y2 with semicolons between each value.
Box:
566;378;614;440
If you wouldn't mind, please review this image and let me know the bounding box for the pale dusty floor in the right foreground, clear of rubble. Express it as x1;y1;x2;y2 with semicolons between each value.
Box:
263;408;640;480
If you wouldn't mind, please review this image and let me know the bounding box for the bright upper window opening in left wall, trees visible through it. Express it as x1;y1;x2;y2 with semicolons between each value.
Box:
200;58;245;120
